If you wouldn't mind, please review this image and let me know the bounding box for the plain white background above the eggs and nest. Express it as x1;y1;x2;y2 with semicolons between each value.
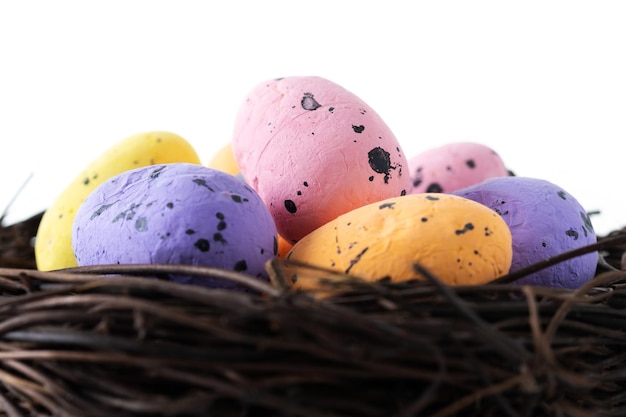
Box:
0;0;626;234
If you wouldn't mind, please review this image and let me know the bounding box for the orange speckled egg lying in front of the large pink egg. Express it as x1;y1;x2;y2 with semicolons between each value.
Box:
286;193;513;289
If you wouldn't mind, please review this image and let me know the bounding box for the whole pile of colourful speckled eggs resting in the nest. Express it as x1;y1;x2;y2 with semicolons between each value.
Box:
35;76;597;289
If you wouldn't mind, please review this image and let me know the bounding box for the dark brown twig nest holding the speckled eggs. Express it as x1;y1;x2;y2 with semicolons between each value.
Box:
0;211;626;417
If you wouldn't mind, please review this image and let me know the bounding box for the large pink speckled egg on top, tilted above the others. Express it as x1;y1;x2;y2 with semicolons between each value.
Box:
232;76;411;243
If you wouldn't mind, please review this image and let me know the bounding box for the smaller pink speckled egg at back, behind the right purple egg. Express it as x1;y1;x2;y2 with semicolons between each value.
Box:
409;142;510;194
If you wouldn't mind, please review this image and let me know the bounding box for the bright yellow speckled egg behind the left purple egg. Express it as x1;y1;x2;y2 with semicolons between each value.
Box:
35;131;201;271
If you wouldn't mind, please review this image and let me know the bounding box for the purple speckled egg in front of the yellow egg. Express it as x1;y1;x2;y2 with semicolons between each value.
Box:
72;163;278;288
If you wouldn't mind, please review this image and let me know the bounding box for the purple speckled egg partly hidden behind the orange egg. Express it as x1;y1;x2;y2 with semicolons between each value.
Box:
452;177;598;289
